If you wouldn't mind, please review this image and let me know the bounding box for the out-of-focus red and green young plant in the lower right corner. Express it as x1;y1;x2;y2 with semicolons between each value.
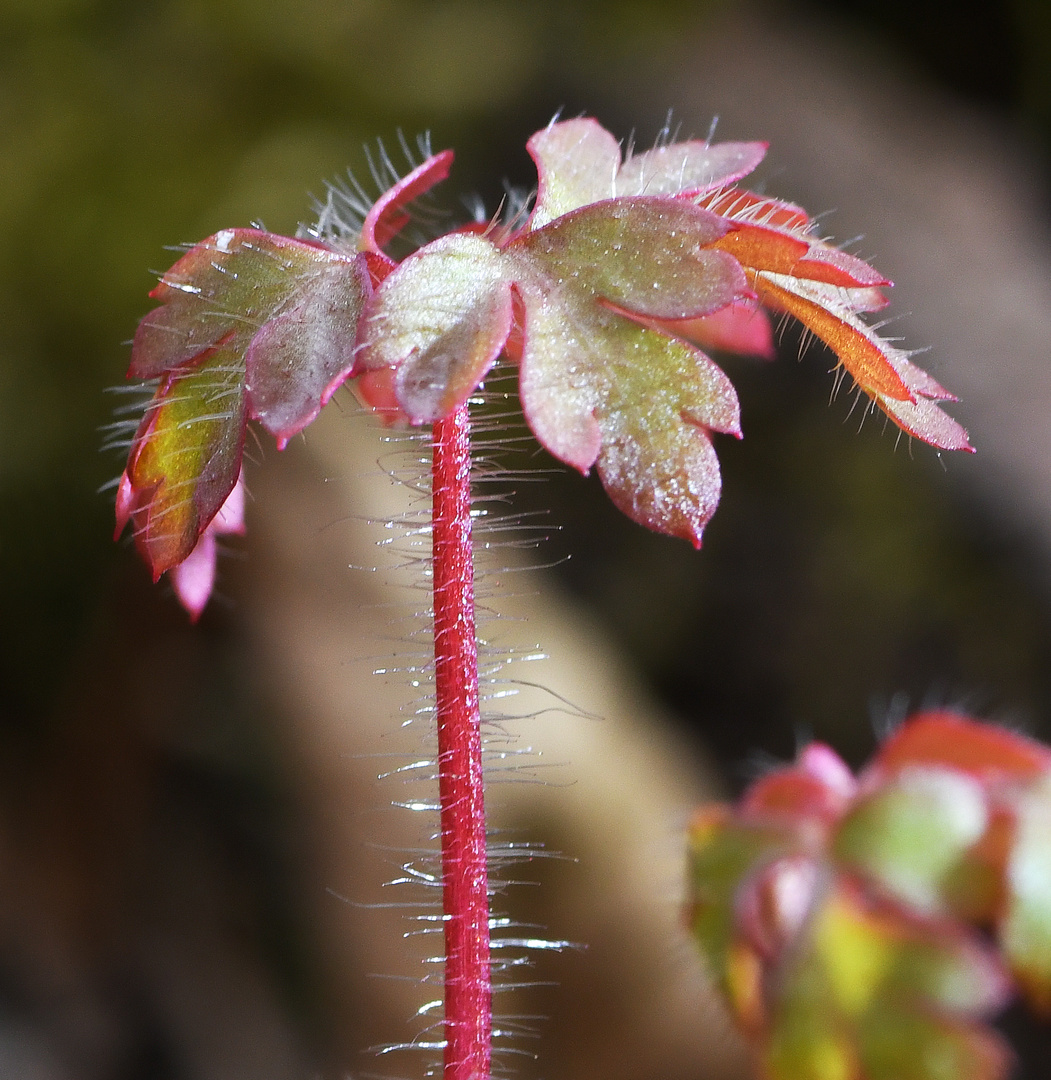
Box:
689;712;1051;1080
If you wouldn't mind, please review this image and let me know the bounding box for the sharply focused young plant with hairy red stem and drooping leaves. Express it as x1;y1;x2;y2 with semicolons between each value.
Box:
110;119;970;1080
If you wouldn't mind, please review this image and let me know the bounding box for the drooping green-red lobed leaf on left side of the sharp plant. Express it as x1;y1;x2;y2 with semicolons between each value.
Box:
118;229;370;578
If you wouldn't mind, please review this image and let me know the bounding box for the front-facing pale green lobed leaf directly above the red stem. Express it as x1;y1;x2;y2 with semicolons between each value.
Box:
359;197;749;543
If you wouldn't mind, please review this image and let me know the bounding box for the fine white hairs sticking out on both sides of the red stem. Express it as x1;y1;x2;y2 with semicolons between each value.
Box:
339;367;591;1076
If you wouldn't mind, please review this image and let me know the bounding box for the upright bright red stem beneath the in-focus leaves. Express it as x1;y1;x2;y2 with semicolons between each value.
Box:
431;405;493;1080
